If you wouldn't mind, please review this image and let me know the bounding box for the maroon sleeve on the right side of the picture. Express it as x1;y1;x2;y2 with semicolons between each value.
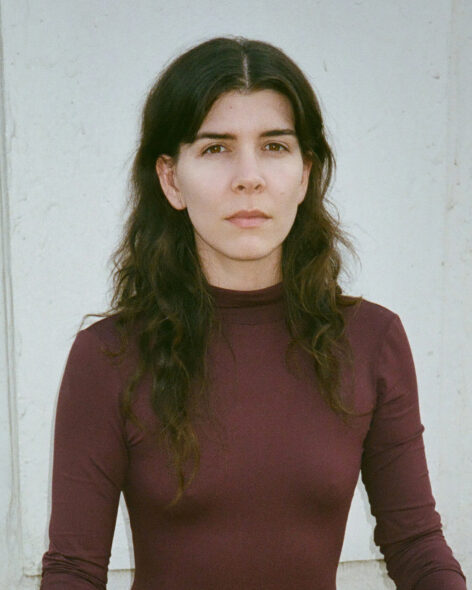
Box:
361;314;466;590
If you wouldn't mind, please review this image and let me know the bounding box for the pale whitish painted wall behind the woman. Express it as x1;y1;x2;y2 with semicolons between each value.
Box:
0;0;472;590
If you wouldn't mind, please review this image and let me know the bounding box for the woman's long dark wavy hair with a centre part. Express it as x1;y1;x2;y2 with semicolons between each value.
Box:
84;37;362;507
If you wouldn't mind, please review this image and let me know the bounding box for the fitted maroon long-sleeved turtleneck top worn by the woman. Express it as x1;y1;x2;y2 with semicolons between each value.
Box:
41;283;466;590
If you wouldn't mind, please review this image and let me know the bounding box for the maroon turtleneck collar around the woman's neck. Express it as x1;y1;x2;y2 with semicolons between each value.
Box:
209;281;285;324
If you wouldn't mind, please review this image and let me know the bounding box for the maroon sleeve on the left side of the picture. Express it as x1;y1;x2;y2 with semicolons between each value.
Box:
40;329;128;590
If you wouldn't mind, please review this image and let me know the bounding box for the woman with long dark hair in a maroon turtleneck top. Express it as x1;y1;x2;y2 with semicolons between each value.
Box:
41;38;465;590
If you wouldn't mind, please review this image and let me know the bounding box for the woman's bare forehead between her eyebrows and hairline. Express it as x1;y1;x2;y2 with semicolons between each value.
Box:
200;90;294;131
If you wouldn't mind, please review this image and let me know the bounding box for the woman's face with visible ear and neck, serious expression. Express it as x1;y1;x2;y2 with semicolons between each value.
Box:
156;90;311;290
